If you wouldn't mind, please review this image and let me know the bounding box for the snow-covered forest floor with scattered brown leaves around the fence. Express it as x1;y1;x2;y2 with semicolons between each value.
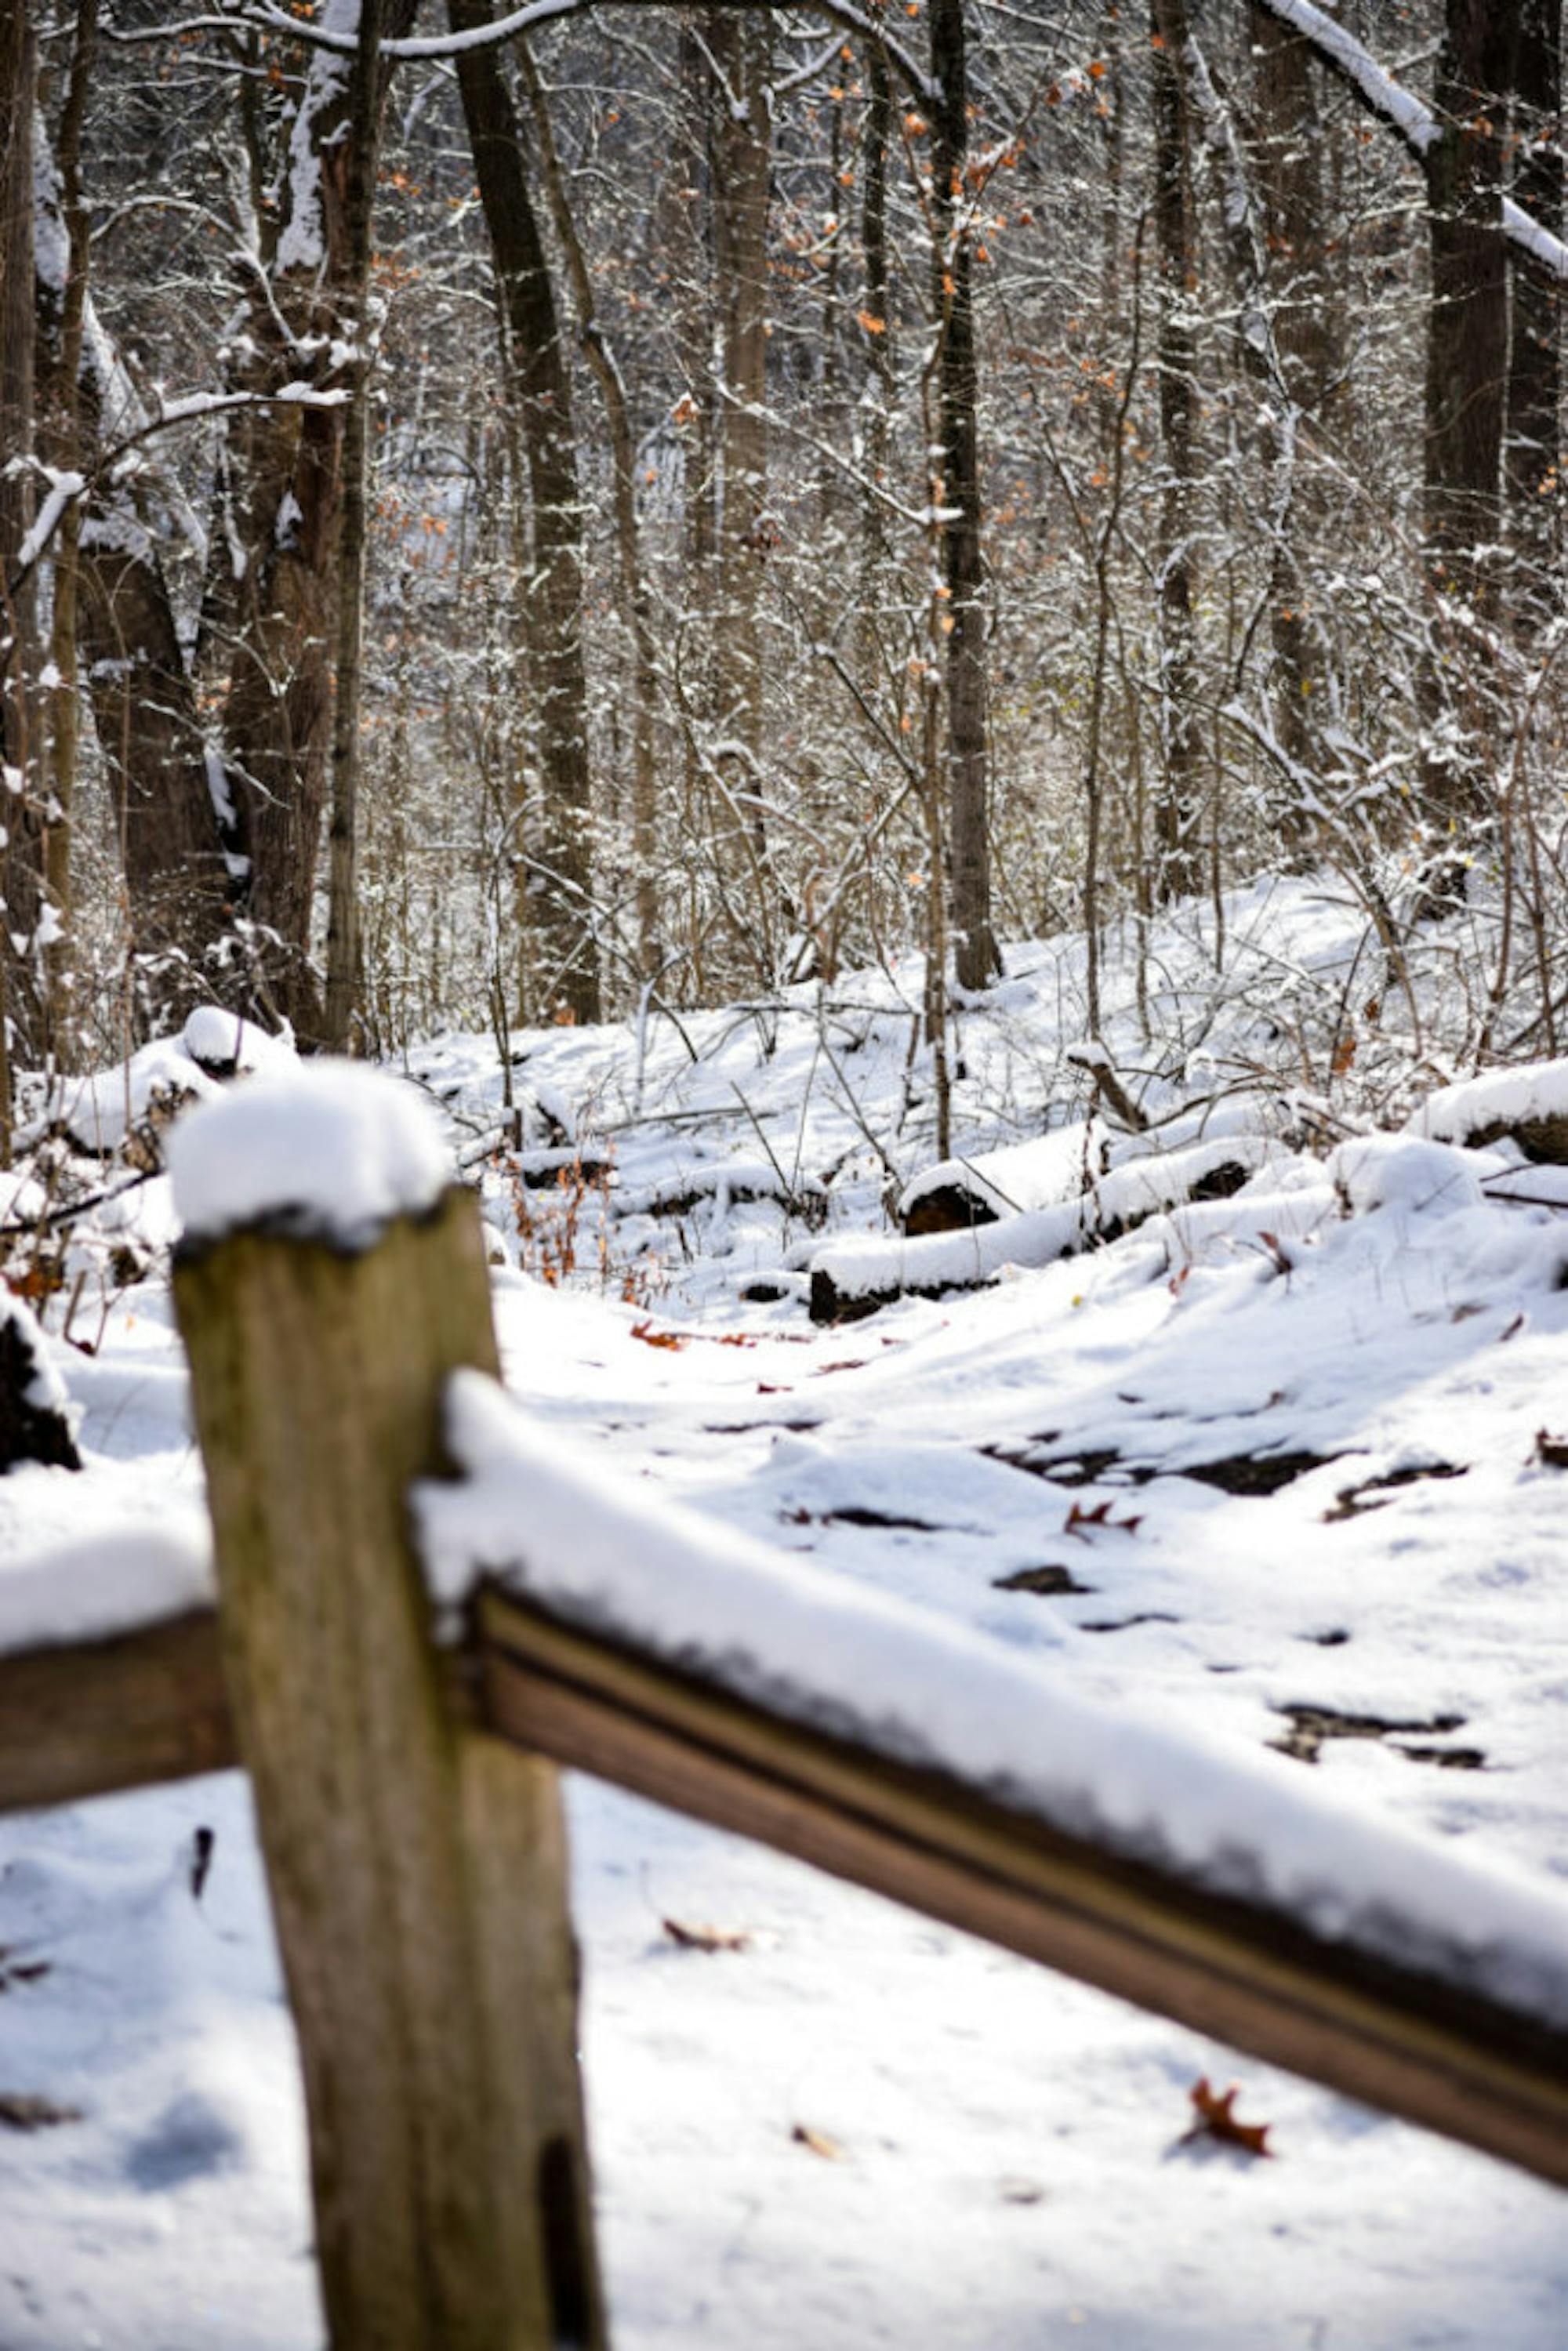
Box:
0;884;1568;2351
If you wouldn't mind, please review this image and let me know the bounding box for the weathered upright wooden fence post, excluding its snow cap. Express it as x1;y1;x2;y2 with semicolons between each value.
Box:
174;1189;607;2351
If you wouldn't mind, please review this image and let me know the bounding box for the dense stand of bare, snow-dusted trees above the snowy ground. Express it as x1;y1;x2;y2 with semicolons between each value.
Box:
0;0;1568;1103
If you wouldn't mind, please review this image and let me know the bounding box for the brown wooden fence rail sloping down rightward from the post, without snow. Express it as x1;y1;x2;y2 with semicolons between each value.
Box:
480;1594;1568;2186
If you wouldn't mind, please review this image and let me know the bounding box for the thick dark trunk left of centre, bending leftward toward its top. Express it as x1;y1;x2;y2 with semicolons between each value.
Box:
447;0;600;1021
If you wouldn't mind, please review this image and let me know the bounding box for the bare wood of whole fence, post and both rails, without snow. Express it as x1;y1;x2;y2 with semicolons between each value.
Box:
0;1156;1568;2351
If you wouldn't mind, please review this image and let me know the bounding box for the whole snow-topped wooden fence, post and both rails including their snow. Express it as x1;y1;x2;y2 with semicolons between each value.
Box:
0;1072;1568;2351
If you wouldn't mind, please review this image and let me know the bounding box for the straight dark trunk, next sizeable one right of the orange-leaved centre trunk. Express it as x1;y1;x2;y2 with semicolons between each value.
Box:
1154;0;1203;898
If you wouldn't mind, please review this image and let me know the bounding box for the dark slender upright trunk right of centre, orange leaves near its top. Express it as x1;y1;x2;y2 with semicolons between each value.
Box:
931;0;1001;988
